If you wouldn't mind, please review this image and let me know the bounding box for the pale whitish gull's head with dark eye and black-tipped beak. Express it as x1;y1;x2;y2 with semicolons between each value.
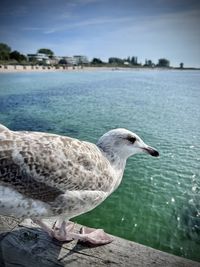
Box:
97;128;159;159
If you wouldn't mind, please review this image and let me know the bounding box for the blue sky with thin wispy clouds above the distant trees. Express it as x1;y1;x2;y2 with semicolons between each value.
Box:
0;0;200;67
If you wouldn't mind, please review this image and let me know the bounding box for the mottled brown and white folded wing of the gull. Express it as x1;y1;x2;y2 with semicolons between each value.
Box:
0;131;111;202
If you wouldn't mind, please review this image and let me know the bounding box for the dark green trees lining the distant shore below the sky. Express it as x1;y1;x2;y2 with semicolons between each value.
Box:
0;43;173;67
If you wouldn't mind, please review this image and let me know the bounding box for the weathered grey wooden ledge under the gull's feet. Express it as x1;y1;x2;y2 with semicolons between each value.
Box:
0;218;200;267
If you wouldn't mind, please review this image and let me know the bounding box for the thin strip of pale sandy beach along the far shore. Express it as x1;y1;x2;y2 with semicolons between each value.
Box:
0;65;200;73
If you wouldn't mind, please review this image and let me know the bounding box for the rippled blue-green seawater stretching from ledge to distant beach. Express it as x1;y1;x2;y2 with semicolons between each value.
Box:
0;70;200;261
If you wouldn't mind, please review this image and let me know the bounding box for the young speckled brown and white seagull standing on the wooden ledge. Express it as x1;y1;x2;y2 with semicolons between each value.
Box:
0;124;159;245
